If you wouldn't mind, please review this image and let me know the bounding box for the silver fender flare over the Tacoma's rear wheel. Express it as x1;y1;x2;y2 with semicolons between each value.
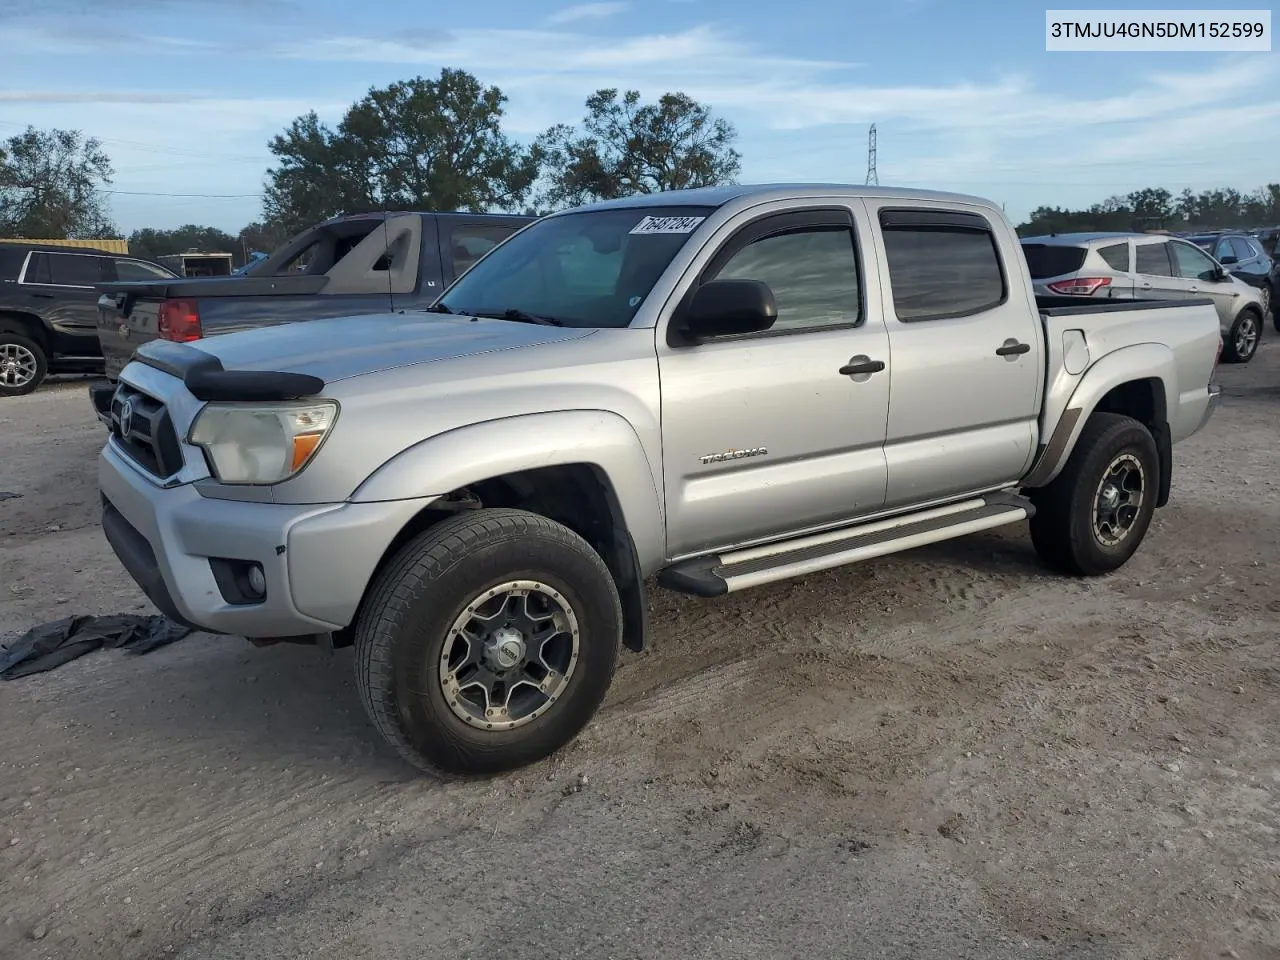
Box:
1023;343;1179;488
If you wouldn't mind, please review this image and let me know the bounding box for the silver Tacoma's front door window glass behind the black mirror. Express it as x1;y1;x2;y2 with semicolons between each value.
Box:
713;227;860;330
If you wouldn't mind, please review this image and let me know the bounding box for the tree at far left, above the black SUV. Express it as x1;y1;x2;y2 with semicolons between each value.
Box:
0;127;115;239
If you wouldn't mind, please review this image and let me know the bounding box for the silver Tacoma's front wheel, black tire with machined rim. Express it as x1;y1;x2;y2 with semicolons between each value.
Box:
356;509;622;773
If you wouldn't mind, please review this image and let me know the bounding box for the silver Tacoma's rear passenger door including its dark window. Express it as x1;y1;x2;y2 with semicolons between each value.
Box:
868;201;1044;507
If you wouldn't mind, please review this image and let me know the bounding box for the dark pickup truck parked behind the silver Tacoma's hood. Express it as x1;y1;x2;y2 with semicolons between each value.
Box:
90;212;535;419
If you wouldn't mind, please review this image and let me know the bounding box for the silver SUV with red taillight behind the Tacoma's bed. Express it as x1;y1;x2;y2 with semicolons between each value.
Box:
1021;233;1266;364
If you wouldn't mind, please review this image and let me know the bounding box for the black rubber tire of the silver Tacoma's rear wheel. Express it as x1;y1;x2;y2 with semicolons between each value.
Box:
1028;413;1160;576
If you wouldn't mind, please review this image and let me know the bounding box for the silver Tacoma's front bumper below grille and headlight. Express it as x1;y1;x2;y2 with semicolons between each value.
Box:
99;440;434;637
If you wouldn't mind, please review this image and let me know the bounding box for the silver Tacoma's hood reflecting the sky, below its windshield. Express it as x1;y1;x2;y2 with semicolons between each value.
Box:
138;312;594;383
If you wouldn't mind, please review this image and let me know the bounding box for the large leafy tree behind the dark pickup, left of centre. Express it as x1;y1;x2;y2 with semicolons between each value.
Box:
264;69;539;234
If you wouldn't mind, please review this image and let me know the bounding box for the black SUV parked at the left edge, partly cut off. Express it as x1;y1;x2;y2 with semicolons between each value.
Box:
0;248;174;397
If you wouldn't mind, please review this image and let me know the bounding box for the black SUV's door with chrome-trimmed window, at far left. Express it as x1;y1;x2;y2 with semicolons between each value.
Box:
19;251;114;357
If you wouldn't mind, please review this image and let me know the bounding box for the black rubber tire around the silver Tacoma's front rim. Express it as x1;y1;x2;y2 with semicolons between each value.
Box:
355;509;622;773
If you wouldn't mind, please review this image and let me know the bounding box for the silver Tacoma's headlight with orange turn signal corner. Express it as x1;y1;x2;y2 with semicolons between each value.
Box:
188;401;338;484
